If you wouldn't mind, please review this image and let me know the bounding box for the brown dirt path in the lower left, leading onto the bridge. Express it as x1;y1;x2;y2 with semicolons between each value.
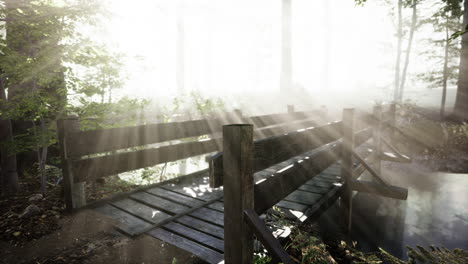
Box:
0;210;202;264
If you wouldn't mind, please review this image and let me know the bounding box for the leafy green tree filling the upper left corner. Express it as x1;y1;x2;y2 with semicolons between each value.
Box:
0;0;123;193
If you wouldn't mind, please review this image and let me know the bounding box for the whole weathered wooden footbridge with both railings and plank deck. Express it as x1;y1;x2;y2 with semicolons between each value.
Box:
58;105;409;263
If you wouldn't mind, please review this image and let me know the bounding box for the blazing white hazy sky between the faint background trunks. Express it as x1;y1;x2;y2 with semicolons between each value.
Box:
90;0;454;107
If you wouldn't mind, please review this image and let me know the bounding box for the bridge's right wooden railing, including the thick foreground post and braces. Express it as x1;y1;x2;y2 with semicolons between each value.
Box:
221;103;407;263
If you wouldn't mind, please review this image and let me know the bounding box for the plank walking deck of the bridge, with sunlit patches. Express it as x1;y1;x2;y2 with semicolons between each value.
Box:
95;148;354;263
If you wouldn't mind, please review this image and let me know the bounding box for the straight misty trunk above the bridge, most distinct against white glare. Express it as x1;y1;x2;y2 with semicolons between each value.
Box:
280;0;292;92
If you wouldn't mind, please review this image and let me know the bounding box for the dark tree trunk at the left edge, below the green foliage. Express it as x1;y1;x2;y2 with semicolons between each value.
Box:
0;78;19;195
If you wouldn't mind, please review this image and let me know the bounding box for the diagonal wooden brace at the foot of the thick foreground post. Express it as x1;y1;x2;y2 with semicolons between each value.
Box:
244;208;295;264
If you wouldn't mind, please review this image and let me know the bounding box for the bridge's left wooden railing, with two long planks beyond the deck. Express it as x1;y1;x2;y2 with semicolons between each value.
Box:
57;106;324;210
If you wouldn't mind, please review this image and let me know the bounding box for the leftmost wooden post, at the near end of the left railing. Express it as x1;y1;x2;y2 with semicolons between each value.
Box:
57;116;86;211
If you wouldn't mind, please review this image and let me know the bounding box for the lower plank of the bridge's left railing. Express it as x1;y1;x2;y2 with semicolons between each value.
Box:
73;139;221;182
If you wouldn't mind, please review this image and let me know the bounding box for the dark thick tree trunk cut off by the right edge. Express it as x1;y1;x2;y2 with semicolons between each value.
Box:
453;0;468;120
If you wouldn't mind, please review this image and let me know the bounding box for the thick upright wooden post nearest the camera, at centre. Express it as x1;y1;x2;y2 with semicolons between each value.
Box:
223;124;254;264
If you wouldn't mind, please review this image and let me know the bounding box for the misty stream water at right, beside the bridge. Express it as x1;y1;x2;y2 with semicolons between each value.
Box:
318;169;468;260
